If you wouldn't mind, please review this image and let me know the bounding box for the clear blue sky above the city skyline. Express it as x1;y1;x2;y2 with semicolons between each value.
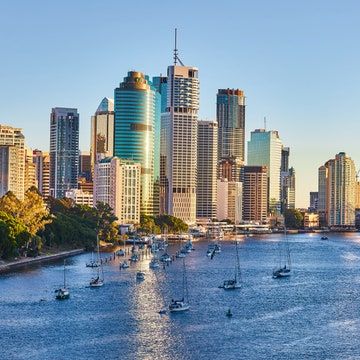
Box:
0;0;360;207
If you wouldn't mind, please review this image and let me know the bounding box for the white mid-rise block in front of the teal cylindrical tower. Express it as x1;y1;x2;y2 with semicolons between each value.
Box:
94;157;141;224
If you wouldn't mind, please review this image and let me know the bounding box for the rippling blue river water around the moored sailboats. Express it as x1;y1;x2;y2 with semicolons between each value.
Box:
0;234;360;360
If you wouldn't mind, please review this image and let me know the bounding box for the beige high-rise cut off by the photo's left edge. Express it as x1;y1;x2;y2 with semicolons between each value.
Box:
0;125;25;200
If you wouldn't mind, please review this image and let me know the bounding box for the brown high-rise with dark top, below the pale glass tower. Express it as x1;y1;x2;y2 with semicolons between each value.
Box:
243;166;268;223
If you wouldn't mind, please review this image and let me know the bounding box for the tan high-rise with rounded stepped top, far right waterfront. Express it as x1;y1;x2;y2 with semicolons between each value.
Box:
318;152;356;227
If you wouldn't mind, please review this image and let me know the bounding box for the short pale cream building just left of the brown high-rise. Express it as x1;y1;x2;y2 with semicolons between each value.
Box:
216;179;242;224
